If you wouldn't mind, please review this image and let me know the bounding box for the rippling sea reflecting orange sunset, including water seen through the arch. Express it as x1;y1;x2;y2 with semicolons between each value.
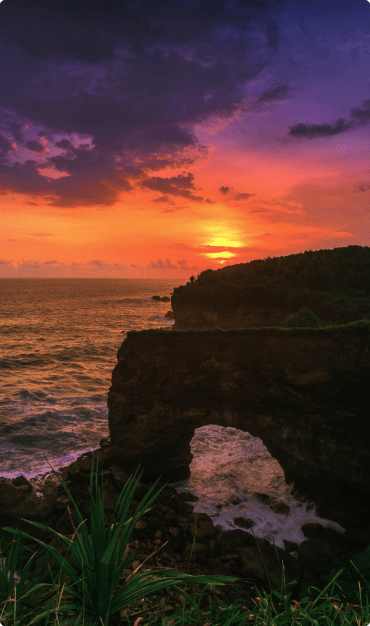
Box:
0;278;344;555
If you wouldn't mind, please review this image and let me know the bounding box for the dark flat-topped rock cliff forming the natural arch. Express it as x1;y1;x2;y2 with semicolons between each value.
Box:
106;321;370;528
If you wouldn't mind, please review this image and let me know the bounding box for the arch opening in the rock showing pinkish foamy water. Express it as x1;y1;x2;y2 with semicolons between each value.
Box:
171;424;326;557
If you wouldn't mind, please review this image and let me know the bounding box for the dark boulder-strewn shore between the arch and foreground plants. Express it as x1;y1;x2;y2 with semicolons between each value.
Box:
0;440;370;609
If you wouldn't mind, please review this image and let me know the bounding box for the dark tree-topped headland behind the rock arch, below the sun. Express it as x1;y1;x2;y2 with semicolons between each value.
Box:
171;246;370;330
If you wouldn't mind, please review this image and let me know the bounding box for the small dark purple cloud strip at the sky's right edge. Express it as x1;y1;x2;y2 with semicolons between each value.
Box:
288;100;370;139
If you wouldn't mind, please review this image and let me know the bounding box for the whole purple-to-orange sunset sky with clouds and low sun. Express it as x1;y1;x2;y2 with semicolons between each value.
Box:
0;0;370;282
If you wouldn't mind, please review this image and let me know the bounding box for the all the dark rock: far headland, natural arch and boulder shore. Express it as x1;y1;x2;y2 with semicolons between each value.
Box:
0;246;370;607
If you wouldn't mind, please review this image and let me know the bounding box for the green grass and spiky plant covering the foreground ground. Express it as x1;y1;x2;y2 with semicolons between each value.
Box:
0;456;370;626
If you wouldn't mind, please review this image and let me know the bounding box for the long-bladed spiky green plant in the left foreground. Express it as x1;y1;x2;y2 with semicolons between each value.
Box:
1;462;236;626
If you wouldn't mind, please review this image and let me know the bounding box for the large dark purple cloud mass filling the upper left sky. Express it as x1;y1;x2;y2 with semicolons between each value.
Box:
0;0;307;207
